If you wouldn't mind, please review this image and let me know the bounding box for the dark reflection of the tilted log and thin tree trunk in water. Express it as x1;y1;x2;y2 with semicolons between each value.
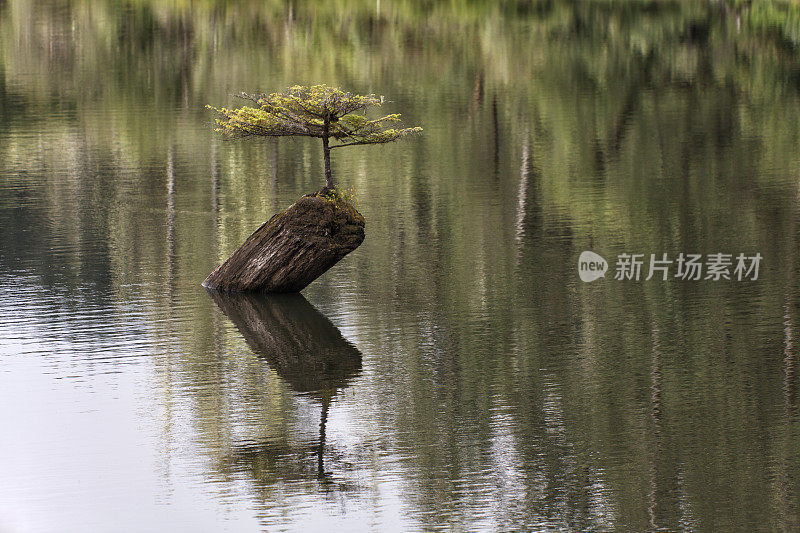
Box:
209;291;361;477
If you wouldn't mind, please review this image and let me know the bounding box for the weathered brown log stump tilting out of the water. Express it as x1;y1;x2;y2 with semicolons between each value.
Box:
203;188;365;292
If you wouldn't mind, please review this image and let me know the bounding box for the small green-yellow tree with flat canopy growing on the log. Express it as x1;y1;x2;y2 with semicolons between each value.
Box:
207;85;422;188
